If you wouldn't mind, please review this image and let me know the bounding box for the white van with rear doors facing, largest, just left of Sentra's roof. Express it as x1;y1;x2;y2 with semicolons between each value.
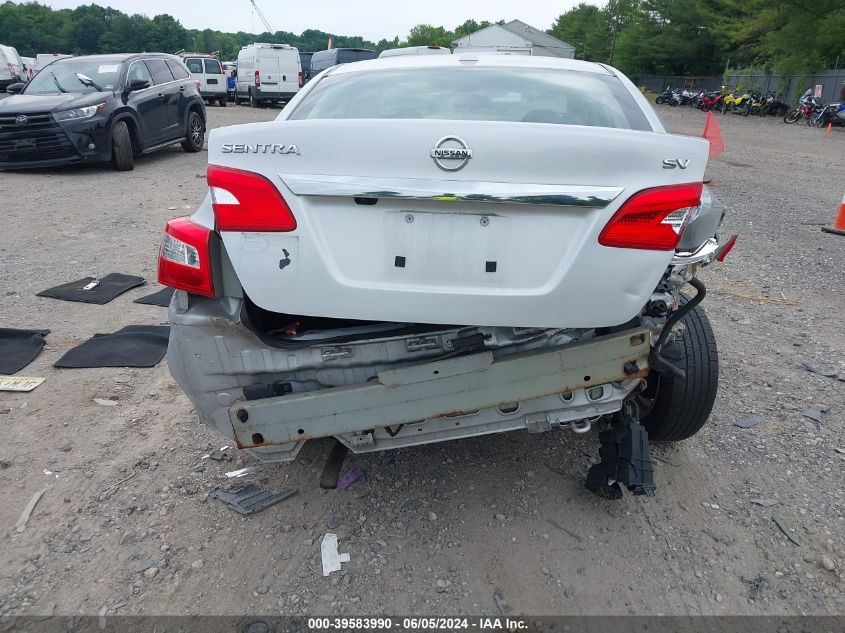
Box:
235;43;302;108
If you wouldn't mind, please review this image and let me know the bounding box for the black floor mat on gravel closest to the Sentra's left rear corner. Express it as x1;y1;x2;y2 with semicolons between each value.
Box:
53;325;170;369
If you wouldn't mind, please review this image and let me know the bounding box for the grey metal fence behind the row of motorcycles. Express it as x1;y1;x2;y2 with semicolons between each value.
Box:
635;68;845;103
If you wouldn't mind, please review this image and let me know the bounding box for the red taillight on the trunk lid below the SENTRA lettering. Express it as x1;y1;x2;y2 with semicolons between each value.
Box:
206;165;296;231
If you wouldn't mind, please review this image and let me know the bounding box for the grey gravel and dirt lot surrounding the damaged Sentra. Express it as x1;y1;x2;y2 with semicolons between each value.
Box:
0;101;845;615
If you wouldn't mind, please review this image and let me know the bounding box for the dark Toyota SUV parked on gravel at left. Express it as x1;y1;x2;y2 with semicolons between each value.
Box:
0;53;205;171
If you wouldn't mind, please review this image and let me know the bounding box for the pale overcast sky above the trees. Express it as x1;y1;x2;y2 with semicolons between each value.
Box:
40;0;592;42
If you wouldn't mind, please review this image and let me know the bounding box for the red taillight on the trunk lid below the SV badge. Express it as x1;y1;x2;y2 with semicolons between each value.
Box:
599;182;702;251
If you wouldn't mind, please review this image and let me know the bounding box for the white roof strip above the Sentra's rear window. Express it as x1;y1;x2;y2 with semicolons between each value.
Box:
329;50;615;75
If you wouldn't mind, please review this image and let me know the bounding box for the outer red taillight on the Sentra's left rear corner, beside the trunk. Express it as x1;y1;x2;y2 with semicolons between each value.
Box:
158;218;214;297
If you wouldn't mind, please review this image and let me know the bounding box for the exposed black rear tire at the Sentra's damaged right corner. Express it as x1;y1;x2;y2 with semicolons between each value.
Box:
637;300;719;442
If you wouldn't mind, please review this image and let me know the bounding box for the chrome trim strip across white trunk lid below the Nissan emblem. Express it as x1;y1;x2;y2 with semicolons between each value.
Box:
279;174;623;209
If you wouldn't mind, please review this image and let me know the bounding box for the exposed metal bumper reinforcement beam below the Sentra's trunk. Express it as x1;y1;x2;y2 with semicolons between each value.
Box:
228;328;650;457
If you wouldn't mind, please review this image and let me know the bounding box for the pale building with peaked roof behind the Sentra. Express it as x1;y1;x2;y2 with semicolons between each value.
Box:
452;20;575;58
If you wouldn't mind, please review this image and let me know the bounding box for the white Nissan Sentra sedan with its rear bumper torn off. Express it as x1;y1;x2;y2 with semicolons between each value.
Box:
159;54;735;496
